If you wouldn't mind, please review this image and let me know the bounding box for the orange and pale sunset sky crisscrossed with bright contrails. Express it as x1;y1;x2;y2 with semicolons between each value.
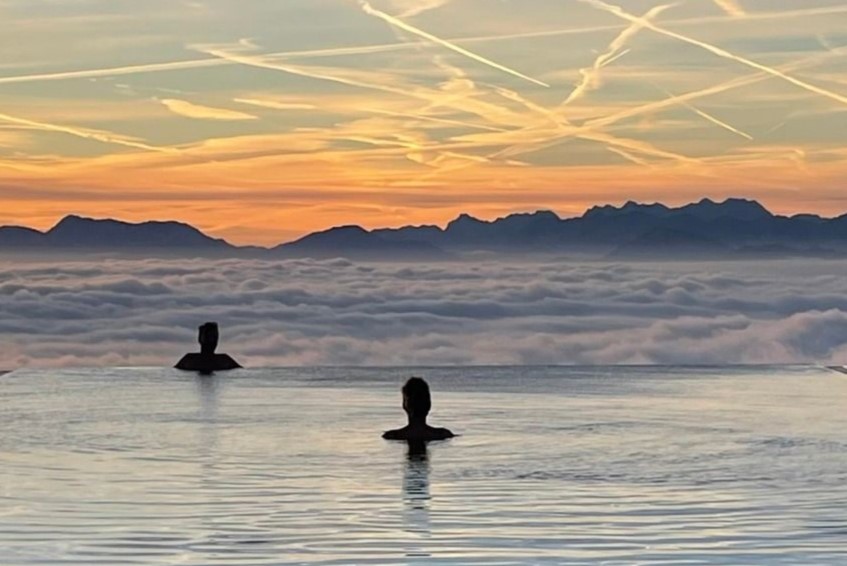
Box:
0;0;847;244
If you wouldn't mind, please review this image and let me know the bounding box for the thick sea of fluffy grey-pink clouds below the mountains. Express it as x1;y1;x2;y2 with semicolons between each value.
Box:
0;259;847;369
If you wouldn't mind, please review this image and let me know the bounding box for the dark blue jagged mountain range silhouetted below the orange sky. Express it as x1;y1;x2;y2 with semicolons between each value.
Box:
0;198;847;260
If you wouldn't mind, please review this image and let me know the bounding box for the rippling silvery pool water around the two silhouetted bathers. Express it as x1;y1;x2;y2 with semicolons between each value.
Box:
0;368;847;566
